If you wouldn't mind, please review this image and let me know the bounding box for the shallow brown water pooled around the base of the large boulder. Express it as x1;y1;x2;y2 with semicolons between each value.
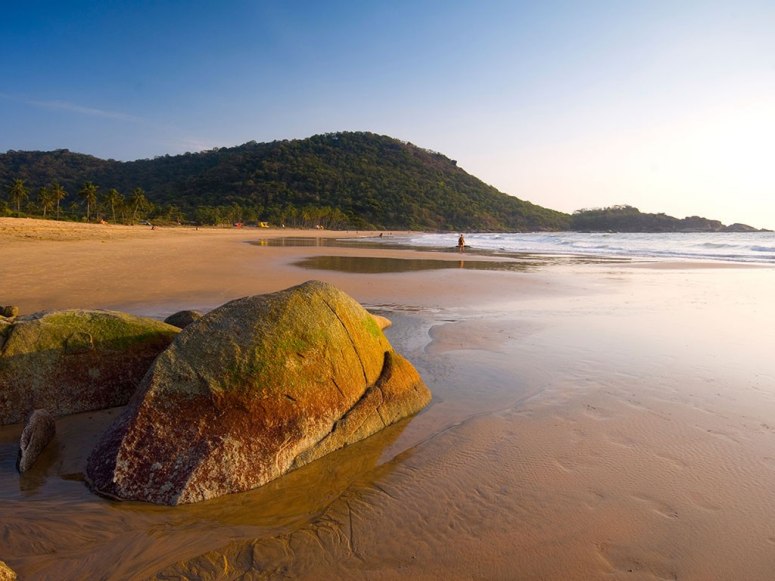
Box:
0;409;411;579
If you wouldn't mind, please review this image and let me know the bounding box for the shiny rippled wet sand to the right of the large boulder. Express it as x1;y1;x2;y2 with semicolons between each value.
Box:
157;269;775;579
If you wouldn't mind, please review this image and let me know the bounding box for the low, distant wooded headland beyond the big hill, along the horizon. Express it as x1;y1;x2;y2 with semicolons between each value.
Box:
570;206;756;232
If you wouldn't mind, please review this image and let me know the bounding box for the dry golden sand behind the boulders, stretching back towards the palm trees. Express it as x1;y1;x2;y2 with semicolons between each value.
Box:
0;218;564;314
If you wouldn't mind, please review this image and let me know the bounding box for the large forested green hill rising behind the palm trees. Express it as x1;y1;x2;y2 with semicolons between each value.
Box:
0;132;570;232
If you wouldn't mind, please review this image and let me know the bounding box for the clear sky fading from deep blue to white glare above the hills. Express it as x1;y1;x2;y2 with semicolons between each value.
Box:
0;0;775;228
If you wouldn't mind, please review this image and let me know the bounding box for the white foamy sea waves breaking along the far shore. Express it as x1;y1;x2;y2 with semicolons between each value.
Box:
376;232;775;264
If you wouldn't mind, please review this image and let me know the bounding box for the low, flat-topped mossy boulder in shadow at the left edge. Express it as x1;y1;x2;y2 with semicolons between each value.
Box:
0;310;180;425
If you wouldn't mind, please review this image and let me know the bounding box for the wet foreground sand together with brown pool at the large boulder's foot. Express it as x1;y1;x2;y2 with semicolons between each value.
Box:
0;264;775;579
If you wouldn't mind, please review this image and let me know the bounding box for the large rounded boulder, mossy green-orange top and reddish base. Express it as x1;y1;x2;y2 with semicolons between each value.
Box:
87;281;430;505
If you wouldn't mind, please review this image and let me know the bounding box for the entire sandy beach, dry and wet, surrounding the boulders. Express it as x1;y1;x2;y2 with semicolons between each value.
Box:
0;219;775;580
